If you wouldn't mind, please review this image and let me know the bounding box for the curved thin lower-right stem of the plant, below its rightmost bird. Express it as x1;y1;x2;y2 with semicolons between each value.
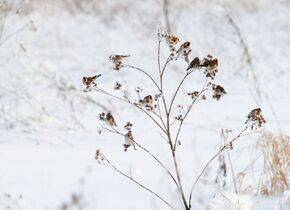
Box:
188;123;256;207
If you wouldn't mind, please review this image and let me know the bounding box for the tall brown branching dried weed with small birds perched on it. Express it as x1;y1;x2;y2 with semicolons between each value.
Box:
84;31;265;210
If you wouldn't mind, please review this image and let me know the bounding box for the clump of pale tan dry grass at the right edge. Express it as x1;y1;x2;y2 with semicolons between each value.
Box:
257;132;290;195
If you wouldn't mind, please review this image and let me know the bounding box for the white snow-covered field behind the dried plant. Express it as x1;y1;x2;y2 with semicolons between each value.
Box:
0;0;290;210
